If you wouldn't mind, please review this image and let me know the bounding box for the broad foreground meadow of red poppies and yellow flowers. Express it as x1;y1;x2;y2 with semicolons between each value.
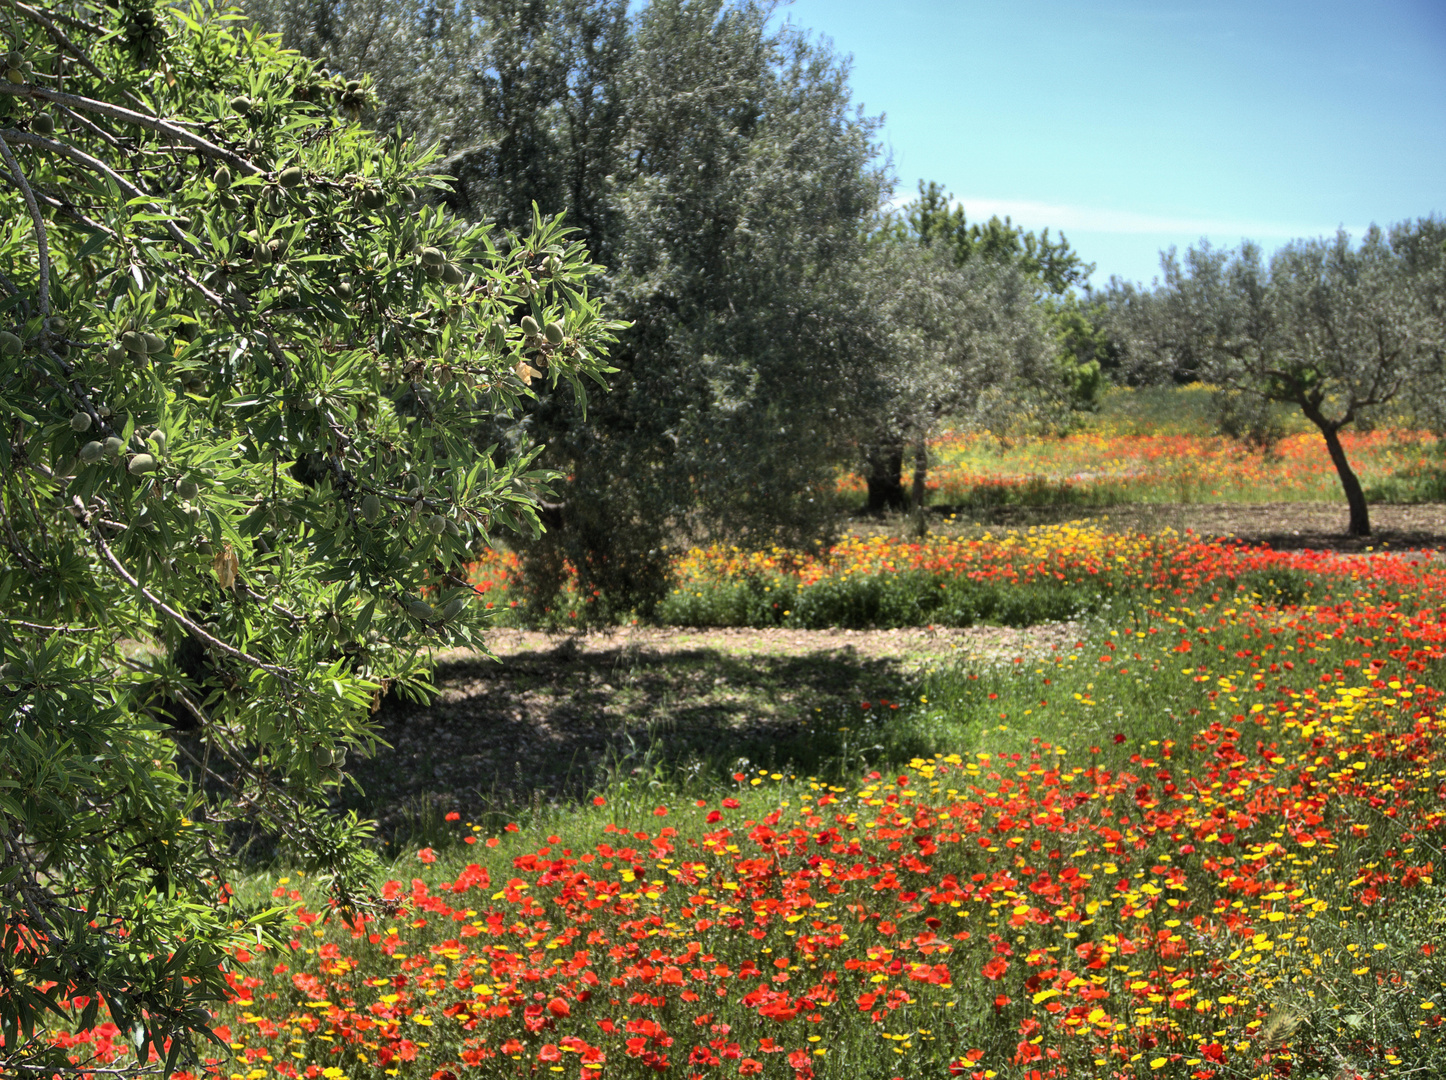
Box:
36;531;1446;1080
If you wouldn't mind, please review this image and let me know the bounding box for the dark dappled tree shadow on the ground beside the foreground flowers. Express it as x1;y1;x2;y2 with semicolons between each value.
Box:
338;639;918;841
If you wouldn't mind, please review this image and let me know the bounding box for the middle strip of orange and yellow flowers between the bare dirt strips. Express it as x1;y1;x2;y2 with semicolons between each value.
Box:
470;522;1440;629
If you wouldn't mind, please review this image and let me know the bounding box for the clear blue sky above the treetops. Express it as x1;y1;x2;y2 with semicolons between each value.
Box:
778;0;1446;285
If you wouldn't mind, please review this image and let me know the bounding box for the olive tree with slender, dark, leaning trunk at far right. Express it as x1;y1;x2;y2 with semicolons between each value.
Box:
1119;220;1446;536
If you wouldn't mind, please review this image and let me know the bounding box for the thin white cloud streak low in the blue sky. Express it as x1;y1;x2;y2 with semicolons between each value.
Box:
899;195;1364;241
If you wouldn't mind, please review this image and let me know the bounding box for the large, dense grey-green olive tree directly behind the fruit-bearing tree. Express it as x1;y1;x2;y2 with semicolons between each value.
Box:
247;0;886;617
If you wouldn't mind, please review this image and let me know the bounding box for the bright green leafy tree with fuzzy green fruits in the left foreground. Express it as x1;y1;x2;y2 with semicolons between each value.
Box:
0;0;616;1076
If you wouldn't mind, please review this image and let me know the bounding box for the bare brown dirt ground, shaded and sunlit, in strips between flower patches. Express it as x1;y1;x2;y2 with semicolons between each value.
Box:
346;503;1446;837
